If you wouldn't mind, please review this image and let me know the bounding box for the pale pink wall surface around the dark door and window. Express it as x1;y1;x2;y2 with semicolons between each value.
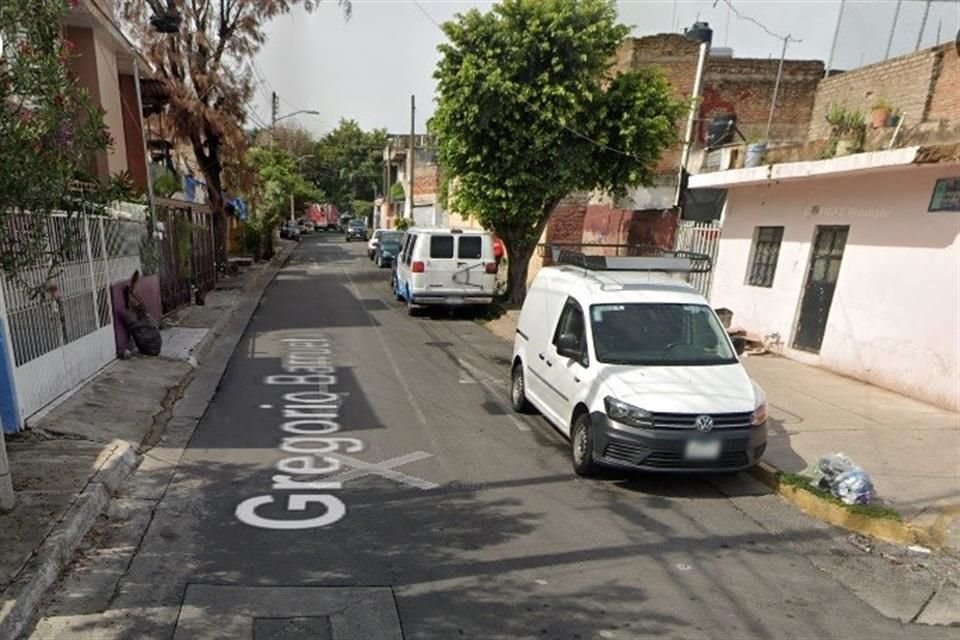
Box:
711;164;960;410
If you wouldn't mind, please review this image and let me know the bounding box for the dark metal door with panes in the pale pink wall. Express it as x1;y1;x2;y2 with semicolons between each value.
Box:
793;226;850;353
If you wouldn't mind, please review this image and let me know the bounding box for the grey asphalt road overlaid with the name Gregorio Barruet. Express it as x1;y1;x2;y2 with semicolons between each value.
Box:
34;235;956;640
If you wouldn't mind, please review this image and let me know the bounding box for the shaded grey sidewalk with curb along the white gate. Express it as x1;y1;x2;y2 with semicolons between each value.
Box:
0;243;293;637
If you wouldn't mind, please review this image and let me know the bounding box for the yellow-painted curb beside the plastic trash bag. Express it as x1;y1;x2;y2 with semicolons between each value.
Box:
750;462;949;550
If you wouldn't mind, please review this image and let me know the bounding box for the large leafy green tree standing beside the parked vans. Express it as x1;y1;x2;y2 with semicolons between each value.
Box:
431;0;684;303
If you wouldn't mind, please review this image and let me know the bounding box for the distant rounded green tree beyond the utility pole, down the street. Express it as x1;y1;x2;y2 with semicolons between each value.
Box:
306;120;388;211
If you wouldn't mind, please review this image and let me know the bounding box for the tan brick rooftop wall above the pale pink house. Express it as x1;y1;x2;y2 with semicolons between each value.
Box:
809;44;958;140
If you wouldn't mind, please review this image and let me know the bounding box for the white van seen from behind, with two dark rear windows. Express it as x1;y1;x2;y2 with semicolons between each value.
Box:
393;228;497;315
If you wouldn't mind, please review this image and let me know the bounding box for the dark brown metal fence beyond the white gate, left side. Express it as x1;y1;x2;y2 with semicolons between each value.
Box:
156;199;217;314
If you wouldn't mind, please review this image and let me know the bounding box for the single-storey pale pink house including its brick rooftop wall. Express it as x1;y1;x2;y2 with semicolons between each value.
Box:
690;44;960;411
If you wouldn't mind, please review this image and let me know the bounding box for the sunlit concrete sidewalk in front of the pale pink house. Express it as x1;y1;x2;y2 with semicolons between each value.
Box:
744;356;960;553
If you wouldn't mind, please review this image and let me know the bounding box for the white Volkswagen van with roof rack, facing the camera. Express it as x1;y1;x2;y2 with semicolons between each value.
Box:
511;256;767;475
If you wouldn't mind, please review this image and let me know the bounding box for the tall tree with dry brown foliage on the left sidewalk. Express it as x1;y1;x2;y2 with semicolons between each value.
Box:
119;0;350;263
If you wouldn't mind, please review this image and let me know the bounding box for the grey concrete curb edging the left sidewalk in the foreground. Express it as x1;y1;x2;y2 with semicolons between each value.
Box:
0;440;139;638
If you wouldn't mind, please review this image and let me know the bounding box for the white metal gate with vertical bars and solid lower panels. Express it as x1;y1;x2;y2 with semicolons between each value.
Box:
0;214;143;422
